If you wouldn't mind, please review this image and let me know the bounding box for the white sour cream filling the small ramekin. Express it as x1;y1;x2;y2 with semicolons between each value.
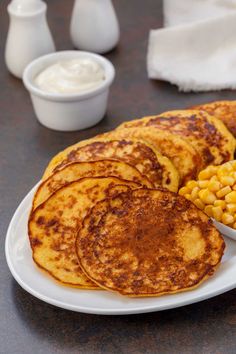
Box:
35;58;105;94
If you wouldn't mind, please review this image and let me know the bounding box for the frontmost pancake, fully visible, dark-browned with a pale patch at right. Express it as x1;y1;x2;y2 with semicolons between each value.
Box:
76;189;225;297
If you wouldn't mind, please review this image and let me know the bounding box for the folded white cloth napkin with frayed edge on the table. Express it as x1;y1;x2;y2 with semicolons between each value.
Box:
147;0;236;92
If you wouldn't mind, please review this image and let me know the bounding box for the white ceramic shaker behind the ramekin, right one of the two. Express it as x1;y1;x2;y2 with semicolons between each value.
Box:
70;0;120;54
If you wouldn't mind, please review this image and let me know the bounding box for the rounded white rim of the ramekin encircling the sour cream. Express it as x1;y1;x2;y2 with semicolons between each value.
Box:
23;50;115;102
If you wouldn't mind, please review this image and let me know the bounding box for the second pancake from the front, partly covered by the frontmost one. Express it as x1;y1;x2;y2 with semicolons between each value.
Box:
28;177;140;289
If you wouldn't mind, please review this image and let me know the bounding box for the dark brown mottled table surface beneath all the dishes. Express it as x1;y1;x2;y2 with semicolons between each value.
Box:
0;0;236;354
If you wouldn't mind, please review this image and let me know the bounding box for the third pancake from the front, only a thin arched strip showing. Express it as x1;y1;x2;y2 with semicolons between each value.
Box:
33;160;152;209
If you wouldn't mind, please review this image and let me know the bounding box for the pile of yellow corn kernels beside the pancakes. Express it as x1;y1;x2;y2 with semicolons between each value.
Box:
179;160;236;229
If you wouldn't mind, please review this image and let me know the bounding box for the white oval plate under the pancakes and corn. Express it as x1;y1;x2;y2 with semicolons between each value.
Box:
5;186;236;315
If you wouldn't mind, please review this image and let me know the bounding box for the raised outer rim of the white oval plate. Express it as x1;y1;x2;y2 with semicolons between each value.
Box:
5;182;236;315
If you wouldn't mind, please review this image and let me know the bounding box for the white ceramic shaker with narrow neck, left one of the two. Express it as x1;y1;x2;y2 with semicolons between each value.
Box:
5;0;55;78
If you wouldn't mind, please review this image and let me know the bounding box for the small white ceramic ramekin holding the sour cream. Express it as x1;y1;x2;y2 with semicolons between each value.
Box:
23;50;115;131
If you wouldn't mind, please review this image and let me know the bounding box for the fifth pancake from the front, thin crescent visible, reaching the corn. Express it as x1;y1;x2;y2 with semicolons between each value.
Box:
99;127;203;185
